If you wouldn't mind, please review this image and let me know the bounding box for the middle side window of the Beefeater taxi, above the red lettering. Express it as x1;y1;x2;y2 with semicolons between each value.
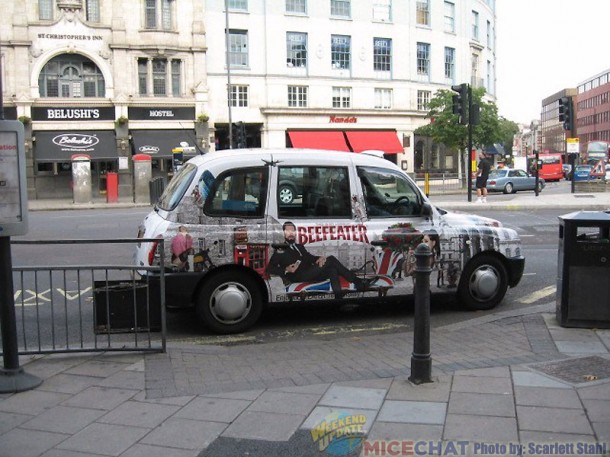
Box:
277;166;352;218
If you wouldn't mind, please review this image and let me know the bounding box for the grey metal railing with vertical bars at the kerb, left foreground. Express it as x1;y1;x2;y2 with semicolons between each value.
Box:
3;239;166;355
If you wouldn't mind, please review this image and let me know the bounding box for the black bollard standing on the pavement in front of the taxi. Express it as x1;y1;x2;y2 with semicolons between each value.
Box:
409;243;432;384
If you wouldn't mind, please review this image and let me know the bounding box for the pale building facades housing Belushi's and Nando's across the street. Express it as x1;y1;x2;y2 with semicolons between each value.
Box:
0;0;496;198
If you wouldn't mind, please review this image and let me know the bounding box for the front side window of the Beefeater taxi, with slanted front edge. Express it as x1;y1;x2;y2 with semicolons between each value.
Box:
358;167;422;219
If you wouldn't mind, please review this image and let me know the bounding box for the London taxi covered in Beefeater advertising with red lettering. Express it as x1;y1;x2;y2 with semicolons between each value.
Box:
136;149;525;333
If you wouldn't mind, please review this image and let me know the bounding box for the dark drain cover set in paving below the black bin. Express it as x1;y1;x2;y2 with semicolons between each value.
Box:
530;355;610;384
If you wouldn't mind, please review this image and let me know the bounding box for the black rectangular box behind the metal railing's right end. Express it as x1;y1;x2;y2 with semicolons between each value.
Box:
93;280;161;334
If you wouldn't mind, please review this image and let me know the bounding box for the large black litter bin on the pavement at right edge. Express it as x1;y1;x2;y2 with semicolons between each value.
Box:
556;211;610;328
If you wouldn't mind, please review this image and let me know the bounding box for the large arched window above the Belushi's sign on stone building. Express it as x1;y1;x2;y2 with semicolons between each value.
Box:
38;54;106;98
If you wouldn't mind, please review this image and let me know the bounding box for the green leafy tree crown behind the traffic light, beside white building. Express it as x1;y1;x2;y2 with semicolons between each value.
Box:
415;88;504;151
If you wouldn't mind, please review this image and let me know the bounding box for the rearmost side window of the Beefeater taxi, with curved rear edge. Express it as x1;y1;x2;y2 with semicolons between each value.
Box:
203;167;268;217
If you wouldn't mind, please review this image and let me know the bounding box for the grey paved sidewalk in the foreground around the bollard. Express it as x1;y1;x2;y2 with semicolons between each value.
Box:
0;303;610;457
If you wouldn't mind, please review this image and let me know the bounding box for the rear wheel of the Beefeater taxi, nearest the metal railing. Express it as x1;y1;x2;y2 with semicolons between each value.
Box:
196;271;263;334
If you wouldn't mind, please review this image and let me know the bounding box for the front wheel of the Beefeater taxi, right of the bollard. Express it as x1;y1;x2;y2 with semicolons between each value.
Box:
457;254;508;310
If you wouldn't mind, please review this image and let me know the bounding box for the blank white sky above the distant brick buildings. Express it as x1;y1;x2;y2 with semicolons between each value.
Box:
496;0;610;125
